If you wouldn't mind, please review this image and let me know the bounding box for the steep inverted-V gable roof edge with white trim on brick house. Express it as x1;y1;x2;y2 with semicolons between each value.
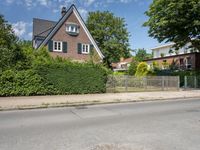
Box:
38;4;104;59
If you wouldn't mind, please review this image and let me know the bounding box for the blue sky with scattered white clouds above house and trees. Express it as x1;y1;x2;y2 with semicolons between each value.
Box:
0;0;159;52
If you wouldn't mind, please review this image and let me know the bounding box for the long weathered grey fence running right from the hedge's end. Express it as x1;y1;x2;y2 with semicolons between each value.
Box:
106;75;179;92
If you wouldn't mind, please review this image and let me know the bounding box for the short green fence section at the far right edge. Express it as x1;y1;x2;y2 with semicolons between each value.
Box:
183;76;200;89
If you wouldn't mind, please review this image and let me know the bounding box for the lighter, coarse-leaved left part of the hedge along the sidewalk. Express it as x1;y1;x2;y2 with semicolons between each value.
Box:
0;70;56;96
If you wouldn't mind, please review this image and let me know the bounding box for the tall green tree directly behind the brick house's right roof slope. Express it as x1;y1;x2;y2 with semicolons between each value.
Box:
86;11;130;66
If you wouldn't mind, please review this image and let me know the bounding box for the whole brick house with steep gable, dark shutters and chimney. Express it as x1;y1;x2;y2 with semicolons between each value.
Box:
32;5;104;62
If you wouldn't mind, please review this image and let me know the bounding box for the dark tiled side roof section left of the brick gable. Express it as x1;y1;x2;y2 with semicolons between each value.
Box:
33;18;57;38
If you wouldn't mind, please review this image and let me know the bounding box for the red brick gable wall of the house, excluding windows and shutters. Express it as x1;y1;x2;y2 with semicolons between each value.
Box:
46;12;100;61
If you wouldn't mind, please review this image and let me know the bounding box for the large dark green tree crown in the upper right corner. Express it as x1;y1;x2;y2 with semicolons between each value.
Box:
144;0;200;51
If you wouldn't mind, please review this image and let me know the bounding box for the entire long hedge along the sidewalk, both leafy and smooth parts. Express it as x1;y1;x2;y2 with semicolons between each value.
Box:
0;62;107;96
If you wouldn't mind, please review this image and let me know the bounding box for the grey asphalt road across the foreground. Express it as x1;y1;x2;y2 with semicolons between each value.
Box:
0;100;200;150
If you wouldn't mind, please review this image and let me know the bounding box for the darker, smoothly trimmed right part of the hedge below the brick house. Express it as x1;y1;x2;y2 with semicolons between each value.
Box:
36;63;107;94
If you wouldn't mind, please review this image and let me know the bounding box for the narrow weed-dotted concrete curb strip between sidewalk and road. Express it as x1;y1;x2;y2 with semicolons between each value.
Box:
0;96;200;111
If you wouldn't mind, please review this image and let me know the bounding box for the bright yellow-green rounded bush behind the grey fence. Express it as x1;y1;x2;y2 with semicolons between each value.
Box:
135;62;149;77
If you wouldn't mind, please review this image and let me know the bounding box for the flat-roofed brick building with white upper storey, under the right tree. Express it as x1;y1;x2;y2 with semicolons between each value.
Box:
144;43;200;70
